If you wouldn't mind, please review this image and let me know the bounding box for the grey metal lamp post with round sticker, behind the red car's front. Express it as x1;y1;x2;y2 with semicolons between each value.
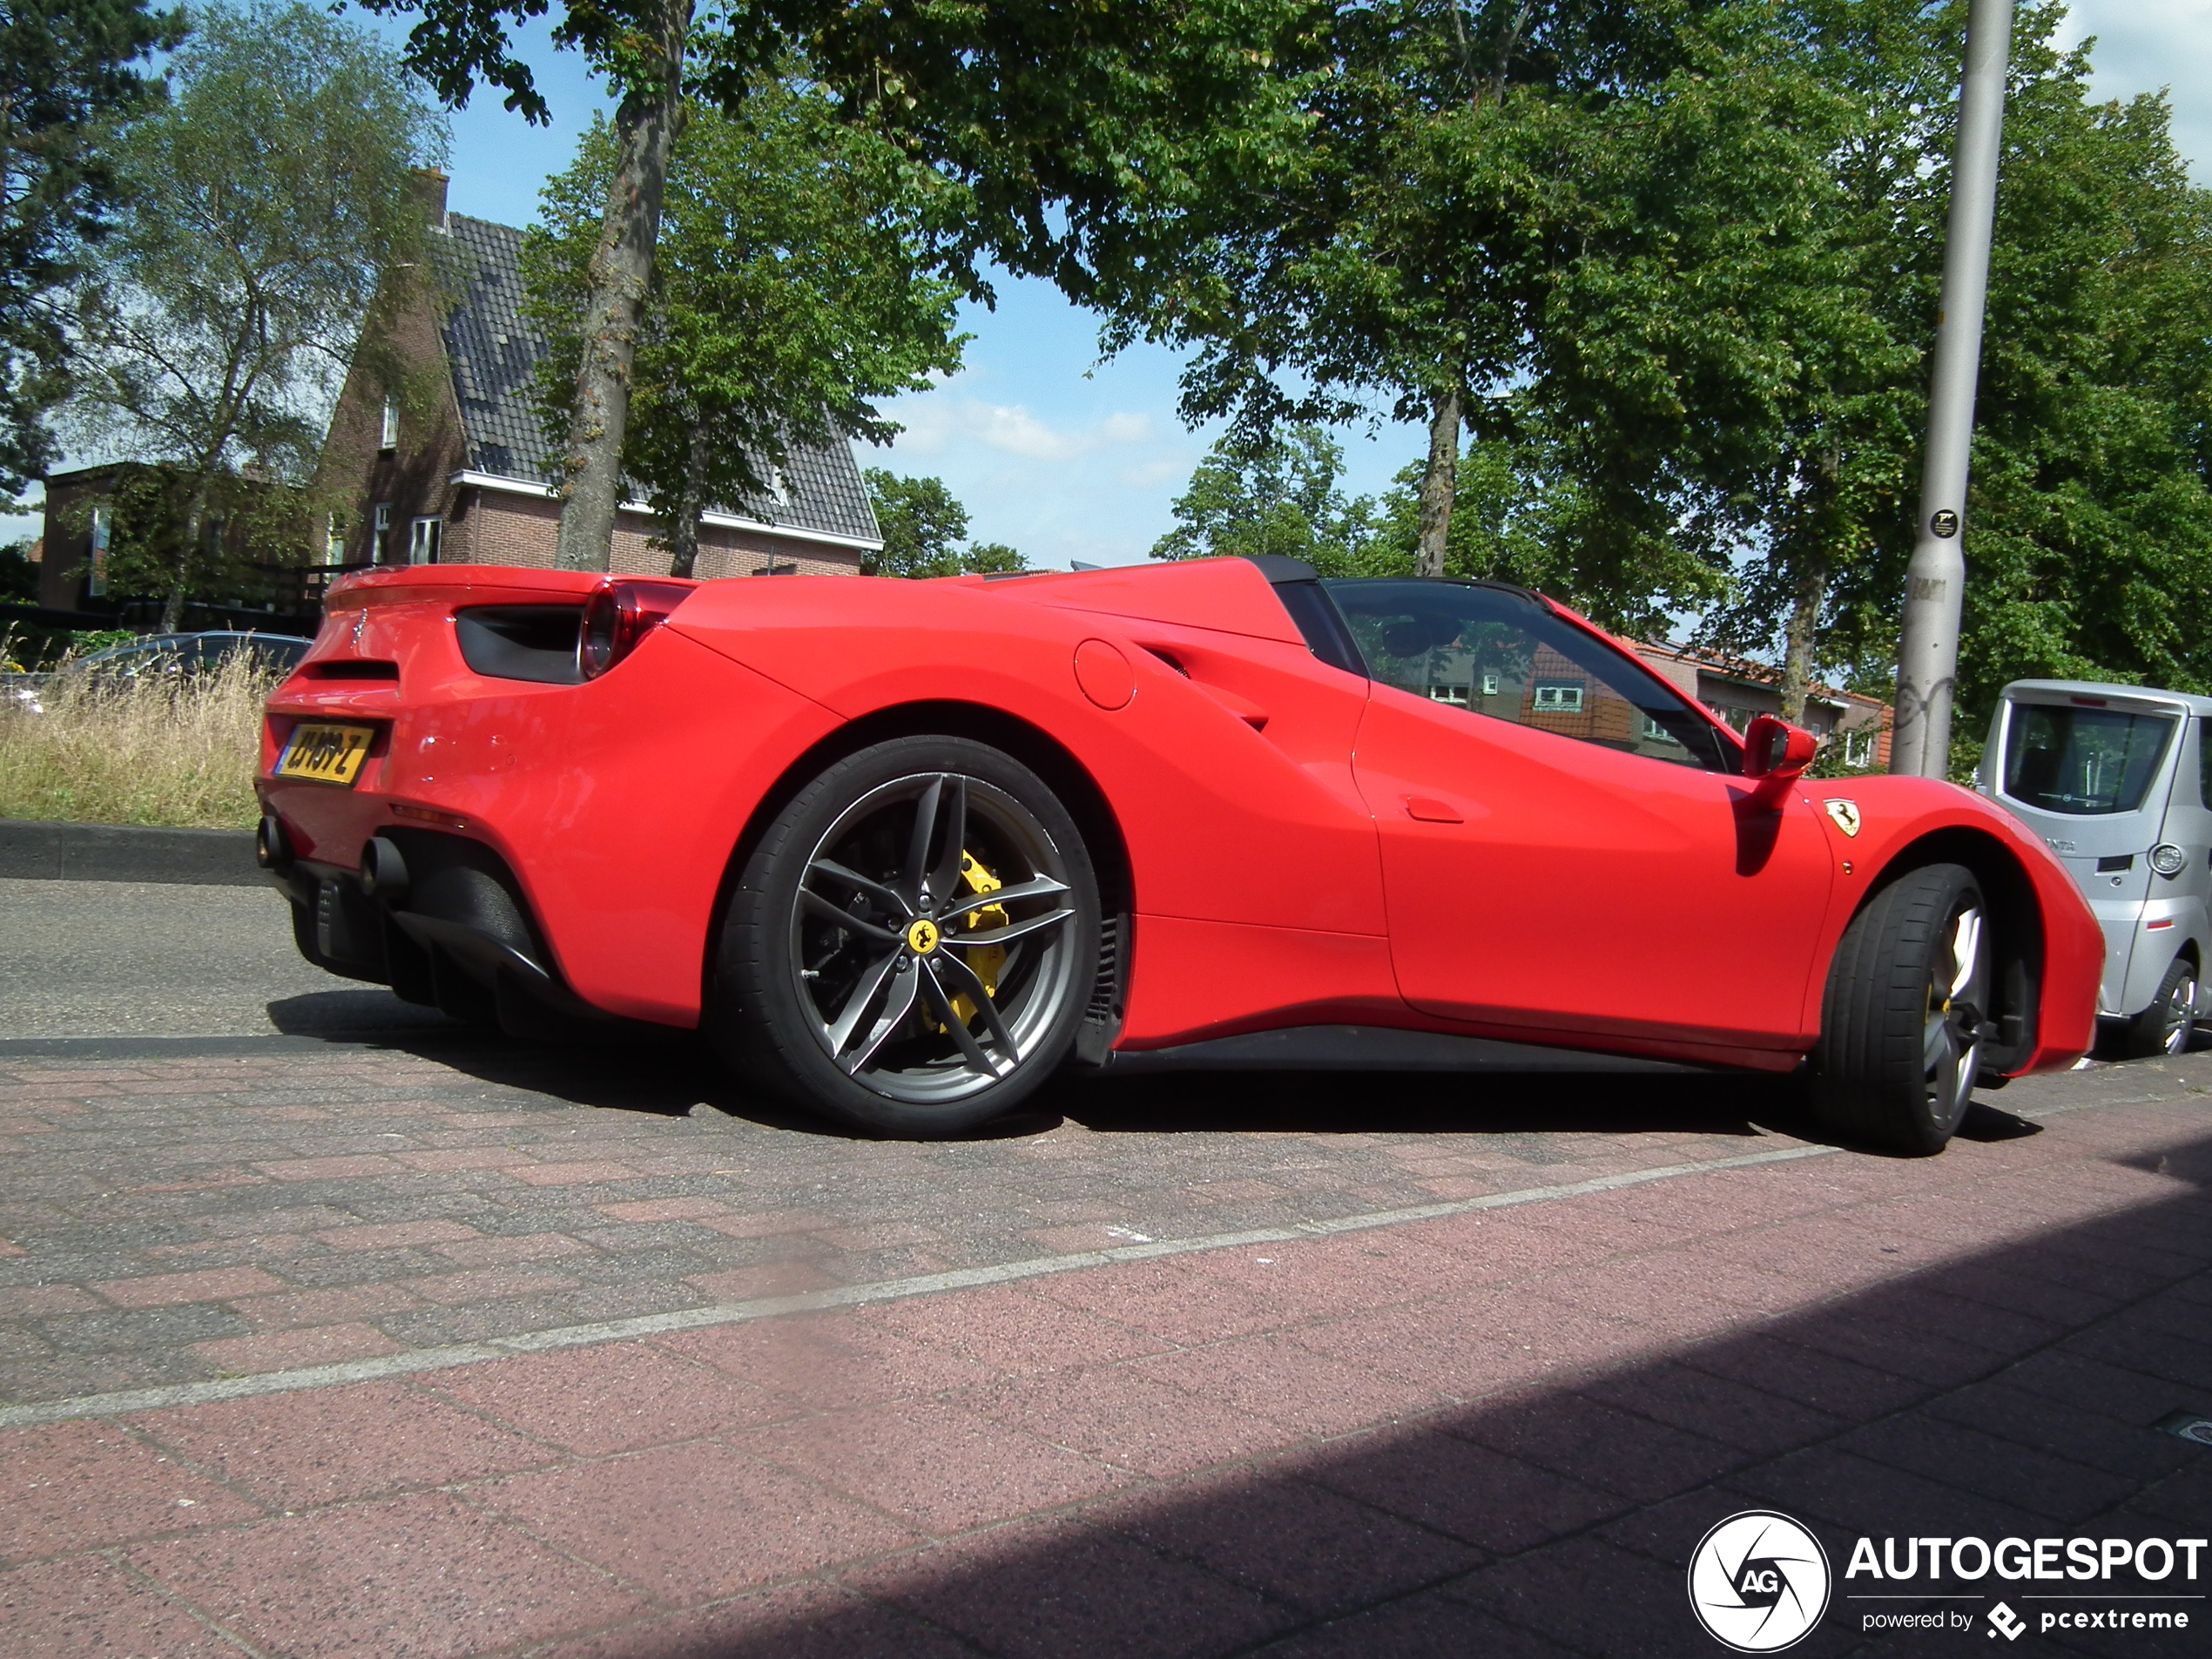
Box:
1889;0;2013;779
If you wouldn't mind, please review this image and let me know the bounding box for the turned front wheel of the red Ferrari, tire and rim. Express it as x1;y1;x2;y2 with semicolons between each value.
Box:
1811;865;1991;1157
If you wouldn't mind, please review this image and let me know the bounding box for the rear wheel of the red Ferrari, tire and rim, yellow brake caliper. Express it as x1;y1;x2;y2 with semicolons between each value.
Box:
710;737;1099;1139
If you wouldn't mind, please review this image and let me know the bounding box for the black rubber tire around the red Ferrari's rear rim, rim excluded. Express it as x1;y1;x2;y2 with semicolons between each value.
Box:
708;737;1099;1139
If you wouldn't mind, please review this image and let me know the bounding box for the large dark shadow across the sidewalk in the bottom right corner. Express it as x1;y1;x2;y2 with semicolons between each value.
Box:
583;1123;2212;1659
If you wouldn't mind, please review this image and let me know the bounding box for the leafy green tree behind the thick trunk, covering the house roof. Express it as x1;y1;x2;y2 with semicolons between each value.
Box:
524;75;964;575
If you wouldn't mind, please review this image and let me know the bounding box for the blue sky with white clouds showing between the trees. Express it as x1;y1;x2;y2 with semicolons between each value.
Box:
0;0;2212;569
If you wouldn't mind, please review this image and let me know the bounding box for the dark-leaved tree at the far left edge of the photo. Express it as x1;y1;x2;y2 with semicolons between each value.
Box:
0;0;184;500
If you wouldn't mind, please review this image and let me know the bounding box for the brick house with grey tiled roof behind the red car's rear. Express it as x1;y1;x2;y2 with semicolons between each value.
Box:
319;175;882;579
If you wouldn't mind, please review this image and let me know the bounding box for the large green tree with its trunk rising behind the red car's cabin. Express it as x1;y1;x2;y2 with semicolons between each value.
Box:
1106;0;1814;593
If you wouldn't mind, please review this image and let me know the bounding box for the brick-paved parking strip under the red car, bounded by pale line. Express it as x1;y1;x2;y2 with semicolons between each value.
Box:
0;1046;1849;1402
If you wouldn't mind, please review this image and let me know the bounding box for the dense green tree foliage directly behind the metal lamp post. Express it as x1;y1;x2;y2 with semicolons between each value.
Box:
1710;0;2212;752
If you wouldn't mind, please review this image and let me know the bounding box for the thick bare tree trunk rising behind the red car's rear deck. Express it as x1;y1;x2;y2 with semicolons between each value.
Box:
553;0;692;570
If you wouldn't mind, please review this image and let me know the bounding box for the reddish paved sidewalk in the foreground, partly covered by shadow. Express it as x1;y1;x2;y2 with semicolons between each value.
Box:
0;1060;2212;1659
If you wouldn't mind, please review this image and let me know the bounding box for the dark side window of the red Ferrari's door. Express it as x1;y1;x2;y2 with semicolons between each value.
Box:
1325;579;1738;772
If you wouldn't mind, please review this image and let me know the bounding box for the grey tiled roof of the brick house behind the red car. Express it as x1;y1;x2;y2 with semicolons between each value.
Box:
445;212;880;542
